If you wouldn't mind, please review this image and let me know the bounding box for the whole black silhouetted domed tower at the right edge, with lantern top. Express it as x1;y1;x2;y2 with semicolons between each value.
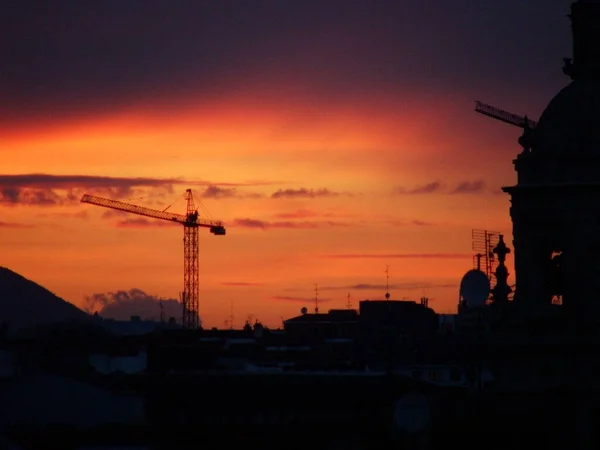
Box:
503;0;600;316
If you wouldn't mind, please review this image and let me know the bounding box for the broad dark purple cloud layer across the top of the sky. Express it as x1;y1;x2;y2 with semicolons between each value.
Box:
0;0;572;124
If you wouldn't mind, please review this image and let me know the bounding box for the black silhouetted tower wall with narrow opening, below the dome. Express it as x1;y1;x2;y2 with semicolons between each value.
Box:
505;185;600;314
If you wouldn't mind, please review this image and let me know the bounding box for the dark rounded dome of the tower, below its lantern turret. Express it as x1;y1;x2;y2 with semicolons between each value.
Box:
532;79;600;156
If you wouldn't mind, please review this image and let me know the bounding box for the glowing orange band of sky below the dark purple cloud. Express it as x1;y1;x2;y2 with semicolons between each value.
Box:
1;88;518;326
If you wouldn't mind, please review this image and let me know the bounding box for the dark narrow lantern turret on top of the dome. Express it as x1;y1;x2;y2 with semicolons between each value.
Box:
569;0;600;79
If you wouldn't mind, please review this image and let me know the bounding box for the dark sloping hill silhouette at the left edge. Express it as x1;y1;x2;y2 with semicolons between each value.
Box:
0;266;89;330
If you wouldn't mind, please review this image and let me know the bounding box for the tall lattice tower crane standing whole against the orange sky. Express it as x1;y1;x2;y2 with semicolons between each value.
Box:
81;189;226;329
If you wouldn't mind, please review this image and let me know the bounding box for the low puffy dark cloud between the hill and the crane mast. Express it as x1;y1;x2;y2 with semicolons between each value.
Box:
84;288;190;321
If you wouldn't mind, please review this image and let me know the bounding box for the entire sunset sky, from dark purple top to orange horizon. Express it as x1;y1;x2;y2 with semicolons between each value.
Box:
0;0;571;327
